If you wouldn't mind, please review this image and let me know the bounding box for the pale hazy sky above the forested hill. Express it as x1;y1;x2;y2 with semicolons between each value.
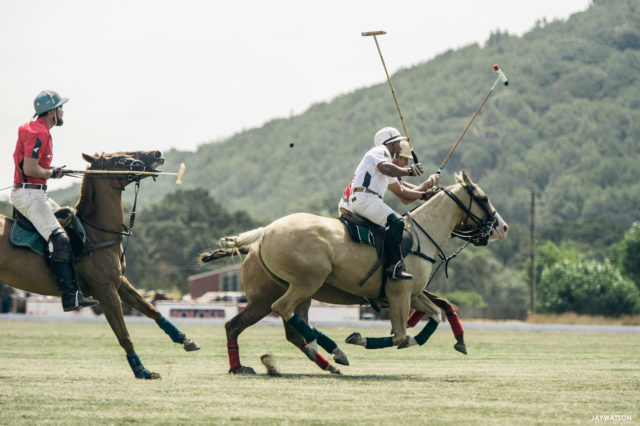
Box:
0;0;590;199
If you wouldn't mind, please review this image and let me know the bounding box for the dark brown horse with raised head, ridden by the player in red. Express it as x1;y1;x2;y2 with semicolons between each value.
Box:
0;151;200;379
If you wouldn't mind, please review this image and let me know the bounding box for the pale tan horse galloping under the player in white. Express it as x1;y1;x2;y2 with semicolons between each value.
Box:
201;172;507;373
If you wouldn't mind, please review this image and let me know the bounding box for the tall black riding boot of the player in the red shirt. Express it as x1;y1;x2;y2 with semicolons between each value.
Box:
49;229;98;312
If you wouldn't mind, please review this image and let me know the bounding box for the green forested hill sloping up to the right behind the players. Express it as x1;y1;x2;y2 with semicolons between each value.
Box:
54;0;640;229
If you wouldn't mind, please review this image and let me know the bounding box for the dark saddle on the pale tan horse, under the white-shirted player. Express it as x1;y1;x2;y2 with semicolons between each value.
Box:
338;211;413;268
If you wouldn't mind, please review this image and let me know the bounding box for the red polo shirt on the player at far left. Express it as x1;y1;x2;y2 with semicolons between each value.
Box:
13;118;53;185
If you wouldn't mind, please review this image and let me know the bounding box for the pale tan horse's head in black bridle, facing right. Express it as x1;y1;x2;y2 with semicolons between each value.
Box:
445;170;509;246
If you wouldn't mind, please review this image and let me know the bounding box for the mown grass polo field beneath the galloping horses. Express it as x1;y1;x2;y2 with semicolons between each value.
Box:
0;321;640;425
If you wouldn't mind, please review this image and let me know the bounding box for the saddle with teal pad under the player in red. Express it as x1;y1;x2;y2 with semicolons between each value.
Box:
9;206;89;260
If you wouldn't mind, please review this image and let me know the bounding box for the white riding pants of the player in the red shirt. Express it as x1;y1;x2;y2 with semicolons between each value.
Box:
11;188;62;241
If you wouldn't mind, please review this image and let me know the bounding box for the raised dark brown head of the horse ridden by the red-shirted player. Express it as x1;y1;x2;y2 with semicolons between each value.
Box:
82;151;164;181
